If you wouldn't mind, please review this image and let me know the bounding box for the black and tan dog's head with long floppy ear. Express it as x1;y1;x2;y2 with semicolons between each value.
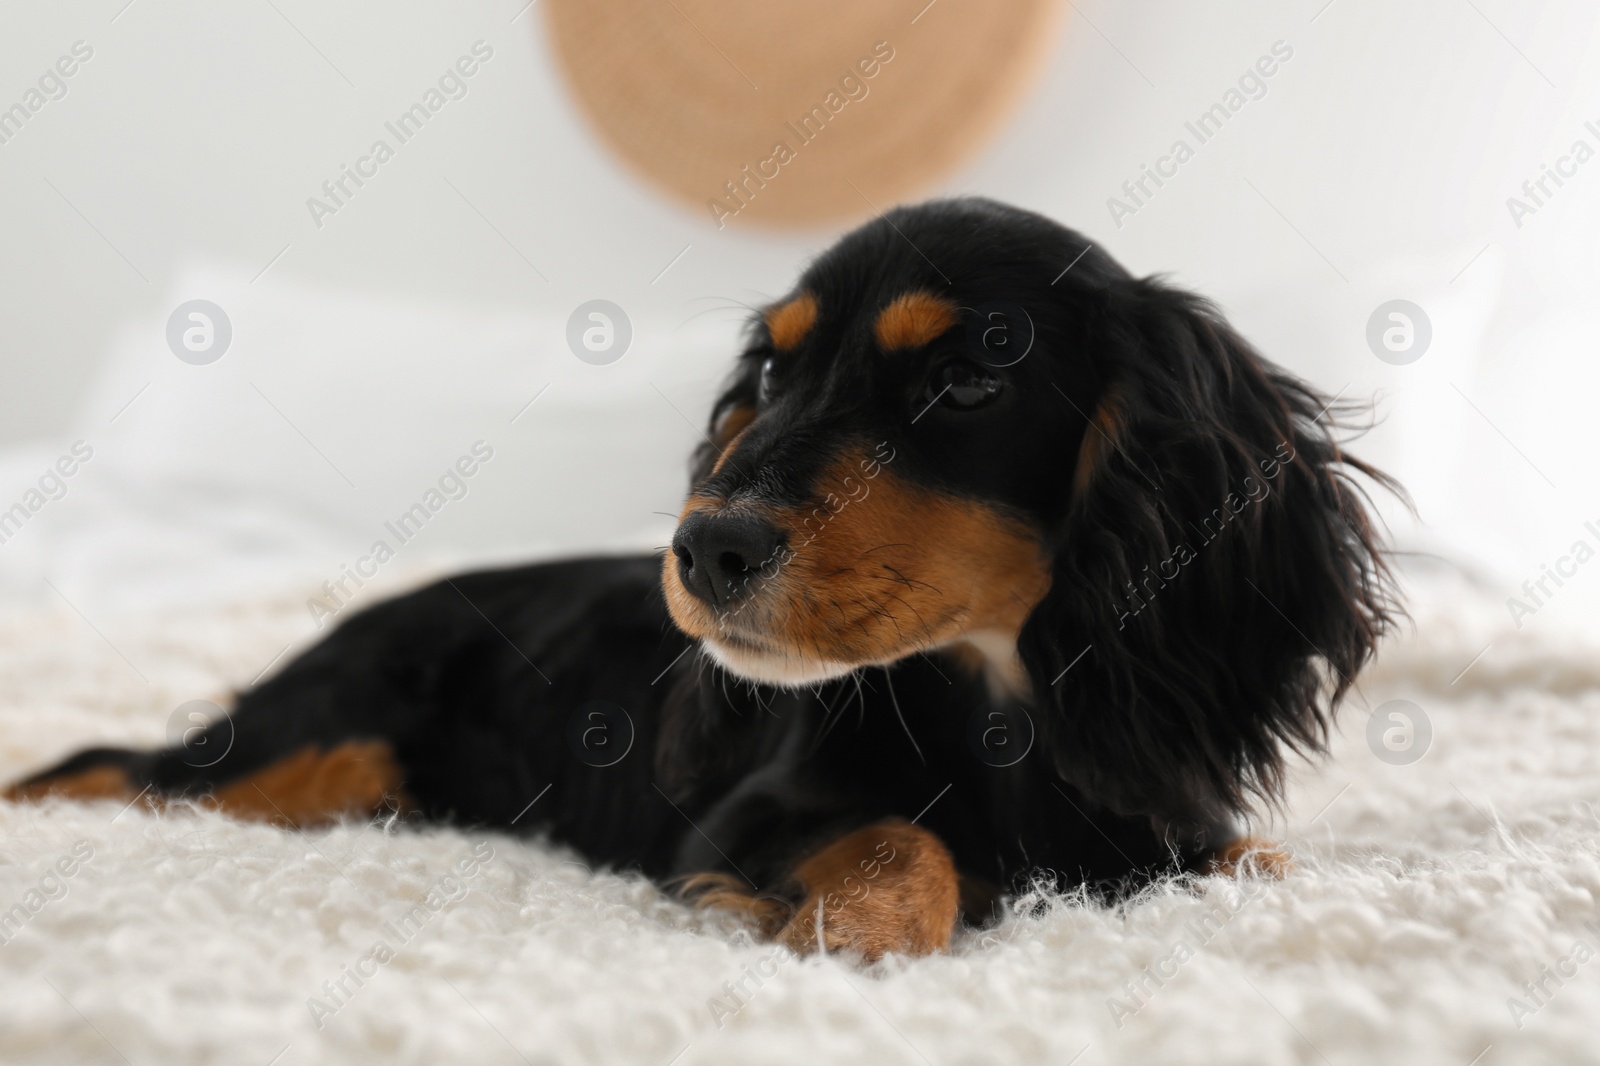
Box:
664;200;1390;810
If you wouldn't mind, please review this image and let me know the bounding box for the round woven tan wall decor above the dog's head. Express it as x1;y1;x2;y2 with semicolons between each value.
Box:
541;0;1058;226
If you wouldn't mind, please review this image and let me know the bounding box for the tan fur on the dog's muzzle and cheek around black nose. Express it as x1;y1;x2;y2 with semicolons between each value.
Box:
662;453;1050;664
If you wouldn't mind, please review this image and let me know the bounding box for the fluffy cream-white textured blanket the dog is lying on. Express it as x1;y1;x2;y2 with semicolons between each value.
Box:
0;560;1600;1066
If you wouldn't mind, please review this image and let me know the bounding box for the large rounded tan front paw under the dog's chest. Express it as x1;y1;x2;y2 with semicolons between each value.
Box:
778;818;960;962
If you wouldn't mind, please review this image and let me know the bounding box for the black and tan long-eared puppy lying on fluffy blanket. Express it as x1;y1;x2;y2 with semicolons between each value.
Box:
8;198;1402;960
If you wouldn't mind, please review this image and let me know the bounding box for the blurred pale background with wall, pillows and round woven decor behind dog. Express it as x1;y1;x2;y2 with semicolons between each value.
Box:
0;0;1600;640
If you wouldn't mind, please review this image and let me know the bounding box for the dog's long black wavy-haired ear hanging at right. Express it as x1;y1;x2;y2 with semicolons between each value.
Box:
1021;280;1403;826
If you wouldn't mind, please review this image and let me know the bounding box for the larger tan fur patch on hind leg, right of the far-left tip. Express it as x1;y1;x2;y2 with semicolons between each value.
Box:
205;741;402;829
